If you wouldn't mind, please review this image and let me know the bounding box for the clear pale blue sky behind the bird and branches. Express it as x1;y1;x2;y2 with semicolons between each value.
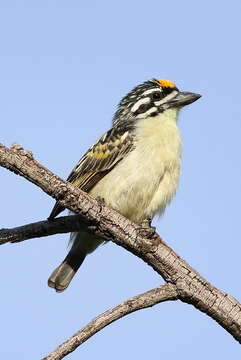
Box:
0;0;241;360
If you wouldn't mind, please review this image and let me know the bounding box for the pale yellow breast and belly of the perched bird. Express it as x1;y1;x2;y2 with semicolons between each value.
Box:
90;109;181;222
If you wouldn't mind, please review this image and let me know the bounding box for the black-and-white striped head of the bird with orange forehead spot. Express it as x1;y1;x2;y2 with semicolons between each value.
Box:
113;79;201;125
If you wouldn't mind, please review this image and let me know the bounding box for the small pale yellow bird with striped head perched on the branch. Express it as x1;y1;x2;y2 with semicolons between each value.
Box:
48;79;201;292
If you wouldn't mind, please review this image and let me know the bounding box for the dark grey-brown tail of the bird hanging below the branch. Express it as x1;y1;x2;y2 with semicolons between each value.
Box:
48;250;87;292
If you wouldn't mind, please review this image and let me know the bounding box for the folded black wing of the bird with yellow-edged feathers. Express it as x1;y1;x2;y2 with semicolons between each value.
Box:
49;127;134;219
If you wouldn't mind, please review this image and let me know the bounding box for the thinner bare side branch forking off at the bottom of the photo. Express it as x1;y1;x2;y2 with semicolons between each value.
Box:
42;284;178;360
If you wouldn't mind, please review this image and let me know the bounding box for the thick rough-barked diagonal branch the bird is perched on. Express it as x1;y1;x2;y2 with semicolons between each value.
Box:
0;145;241;342
